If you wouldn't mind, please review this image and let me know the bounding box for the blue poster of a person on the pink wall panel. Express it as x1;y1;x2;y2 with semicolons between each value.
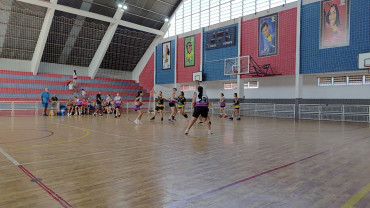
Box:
258;14;279;57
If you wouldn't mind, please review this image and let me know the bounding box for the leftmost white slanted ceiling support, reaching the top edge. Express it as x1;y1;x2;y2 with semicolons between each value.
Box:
31;0;58;75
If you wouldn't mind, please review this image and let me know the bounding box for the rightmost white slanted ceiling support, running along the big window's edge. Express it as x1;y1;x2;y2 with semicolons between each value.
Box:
132;0;185;82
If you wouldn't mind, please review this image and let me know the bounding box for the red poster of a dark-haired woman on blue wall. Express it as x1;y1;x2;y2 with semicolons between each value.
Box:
320;0;349;49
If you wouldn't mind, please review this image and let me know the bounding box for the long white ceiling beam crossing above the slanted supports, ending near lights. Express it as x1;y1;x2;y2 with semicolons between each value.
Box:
18;0;164;35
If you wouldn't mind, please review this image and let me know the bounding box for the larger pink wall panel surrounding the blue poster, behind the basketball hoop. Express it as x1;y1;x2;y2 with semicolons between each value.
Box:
241;8;297;78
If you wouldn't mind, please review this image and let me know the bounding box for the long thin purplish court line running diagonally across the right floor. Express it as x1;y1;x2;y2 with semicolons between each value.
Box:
170;136;370;207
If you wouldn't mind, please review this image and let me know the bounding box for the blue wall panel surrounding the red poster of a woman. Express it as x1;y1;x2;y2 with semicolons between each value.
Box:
301;0;370;74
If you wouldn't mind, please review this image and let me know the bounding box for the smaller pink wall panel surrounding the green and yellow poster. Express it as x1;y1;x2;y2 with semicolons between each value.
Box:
176;33;201;83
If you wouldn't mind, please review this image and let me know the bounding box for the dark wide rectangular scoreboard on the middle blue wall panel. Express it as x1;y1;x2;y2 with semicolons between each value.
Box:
206;26;236;50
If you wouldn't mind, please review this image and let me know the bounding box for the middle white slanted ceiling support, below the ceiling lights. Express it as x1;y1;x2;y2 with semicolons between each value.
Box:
89;9;123;79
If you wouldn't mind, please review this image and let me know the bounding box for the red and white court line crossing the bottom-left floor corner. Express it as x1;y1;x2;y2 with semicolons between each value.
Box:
0;148;73;208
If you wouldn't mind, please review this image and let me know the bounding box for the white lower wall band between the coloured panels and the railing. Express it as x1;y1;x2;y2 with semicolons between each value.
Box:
157;72;370;99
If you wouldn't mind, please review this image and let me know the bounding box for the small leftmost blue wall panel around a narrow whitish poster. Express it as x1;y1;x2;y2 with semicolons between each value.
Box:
155;40;176;84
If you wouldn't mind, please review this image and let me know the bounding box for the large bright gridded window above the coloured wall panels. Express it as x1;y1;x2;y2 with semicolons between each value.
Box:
165;0;297;37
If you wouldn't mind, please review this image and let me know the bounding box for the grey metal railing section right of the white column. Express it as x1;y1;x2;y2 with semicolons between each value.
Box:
299;104;370;122
